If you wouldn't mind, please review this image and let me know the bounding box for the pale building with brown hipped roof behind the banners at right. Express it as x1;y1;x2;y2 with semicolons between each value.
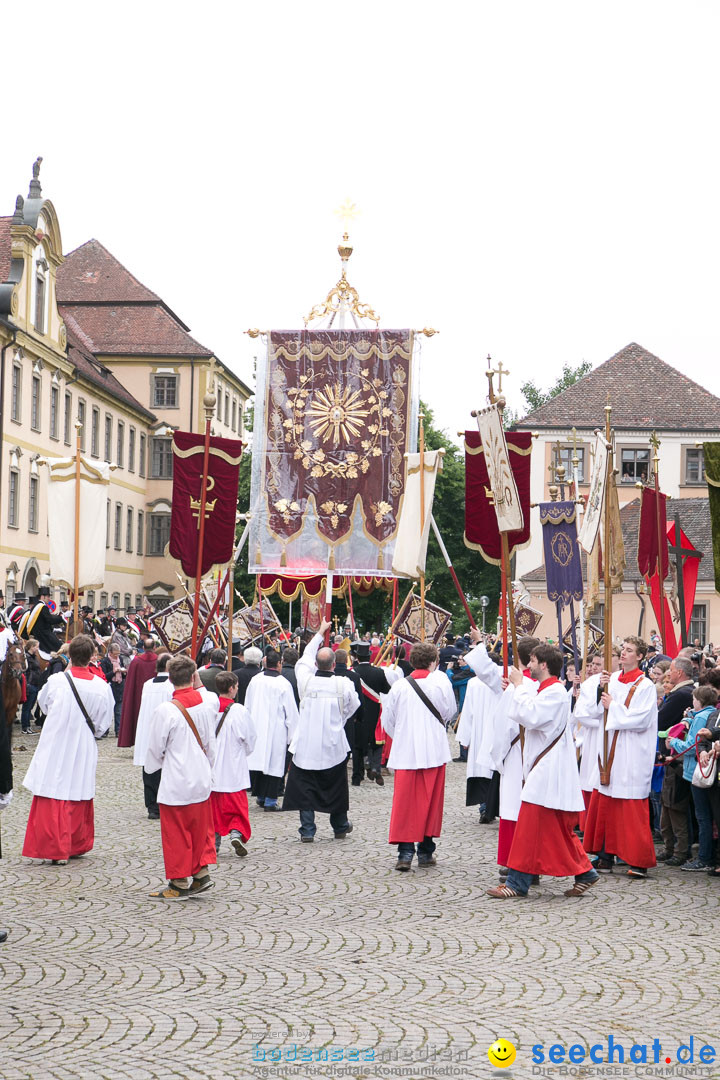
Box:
515;343;720;640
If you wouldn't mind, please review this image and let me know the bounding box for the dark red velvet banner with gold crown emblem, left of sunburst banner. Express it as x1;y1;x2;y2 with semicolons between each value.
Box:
168;431;243;578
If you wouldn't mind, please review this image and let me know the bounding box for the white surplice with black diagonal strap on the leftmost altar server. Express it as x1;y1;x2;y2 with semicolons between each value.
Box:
23;670;114;801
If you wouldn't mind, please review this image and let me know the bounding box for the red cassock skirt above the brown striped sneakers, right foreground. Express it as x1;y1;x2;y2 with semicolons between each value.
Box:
507;802;590;877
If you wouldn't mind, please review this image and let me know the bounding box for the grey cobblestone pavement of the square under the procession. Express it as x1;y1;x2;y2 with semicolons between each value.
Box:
0;735;720;1080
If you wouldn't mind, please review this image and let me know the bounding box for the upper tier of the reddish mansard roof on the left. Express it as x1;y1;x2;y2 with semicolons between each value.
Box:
57;240;162;303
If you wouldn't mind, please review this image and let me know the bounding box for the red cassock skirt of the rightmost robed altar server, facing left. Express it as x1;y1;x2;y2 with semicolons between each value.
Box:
583;789;657;869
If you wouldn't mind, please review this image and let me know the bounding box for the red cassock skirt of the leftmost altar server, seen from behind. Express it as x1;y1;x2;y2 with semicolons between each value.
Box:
23;795;95;859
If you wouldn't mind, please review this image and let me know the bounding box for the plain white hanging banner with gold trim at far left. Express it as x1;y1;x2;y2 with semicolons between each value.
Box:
47;456;110;592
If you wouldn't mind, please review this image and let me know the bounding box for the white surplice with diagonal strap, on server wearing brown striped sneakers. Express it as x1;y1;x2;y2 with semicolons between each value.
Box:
510;683;585;811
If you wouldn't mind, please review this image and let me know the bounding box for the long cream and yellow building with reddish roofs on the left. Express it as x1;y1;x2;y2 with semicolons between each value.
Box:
0;162;250;609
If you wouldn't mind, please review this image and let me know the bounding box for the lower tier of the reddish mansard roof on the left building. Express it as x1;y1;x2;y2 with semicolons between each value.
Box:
58;303;213;357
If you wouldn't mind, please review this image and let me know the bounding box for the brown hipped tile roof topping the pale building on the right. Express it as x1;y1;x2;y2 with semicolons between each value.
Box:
517;342;720;431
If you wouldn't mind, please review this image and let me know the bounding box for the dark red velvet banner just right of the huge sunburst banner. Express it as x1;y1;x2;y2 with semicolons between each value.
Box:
464;431;532;566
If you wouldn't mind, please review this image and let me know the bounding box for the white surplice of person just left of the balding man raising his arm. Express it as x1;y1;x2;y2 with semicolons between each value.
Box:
243;672;298;777
